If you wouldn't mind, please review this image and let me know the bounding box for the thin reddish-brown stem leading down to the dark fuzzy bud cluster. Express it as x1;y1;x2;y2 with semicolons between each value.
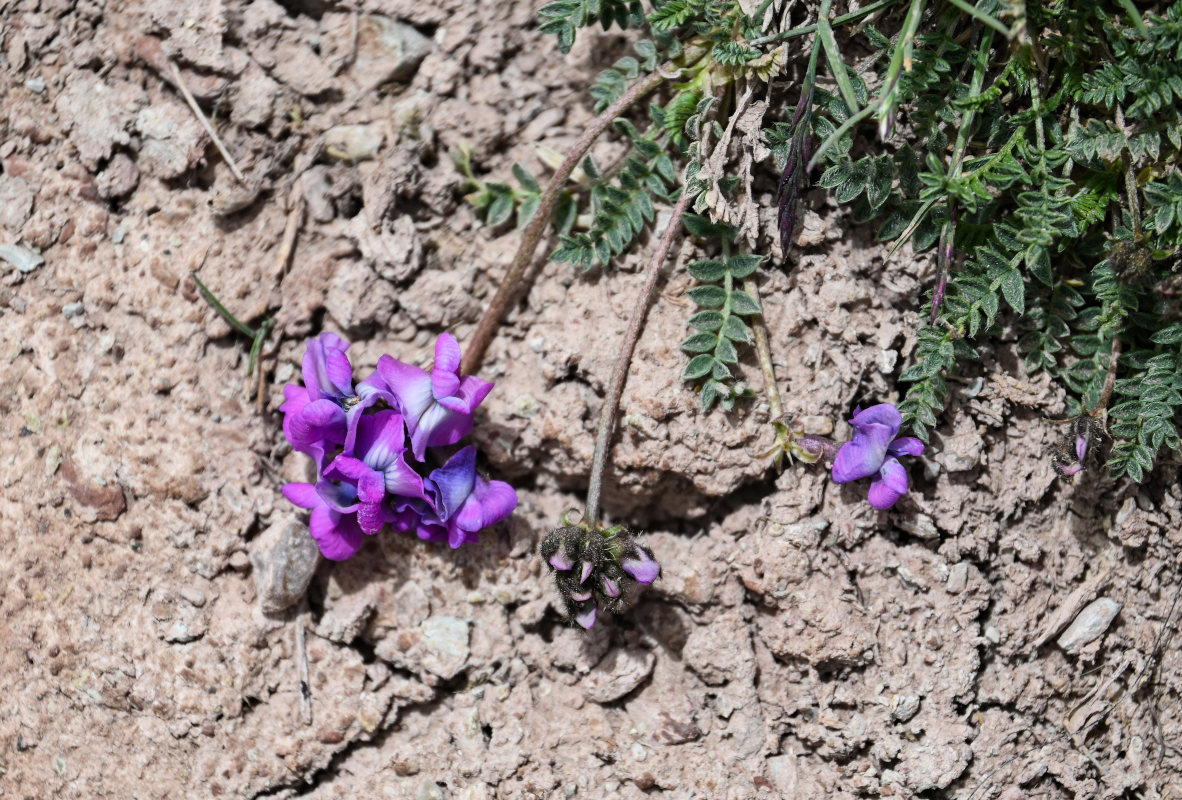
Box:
583;189;689;527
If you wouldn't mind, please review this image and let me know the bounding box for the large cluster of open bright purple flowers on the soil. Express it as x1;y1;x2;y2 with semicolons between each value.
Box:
280;333;517;561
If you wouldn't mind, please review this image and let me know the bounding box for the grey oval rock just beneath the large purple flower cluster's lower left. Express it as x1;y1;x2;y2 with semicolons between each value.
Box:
251;515;320;613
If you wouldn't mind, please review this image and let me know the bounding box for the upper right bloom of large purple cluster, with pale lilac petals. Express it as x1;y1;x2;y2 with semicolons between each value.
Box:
377;333;493;461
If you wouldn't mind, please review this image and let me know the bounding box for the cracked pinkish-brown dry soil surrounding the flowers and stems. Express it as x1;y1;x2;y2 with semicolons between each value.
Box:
0;0;1182;800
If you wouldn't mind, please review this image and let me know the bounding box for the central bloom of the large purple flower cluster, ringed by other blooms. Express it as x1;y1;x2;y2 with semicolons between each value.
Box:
324;409;427;534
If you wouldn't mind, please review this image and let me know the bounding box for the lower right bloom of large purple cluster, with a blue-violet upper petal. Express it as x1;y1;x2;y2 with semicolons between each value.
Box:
418;444;517;547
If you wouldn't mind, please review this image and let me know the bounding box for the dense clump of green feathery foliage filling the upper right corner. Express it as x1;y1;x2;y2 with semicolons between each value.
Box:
813;0;1182;481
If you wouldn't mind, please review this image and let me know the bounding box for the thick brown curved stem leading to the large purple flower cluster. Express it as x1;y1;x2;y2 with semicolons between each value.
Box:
460;65;673;375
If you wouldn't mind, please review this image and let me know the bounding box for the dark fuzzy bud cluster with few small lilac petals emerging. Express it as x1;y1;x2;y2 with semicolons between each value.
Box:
539;525;661;629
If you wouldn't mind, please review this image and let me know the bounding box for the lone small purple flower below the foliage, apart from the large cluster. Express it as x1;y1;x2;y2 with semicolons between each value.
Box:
833;403;923;509
